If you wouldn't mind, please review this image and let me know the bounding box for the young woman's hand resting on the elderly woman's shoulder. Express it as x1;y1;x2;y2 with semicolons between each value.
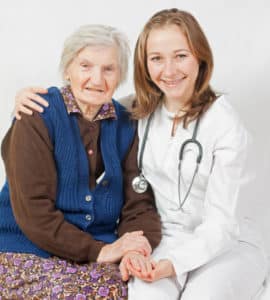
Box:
14;87;49;120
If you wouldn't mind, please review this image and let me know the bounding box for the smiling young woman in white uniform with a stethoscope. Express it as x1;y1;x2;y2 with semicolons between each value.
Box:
12;9;268;300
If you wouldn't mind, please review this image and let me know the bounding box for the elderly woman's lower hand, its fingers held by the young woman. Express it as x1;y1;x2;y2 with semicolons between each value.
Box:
119;251;155;281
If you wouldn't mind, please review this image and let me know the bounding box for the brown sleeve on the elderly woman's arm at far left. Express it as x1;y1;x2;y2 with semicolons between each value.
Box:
2;113;104;262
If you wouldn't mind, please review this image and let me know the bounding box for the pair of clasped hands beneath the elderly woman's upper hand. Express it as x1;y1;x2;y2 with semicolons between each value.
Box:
119;251;175;282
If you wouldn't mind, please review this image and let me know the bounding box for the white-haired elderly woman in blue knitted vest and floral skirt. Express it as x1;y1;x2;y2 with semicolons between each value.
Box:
0;25;161;299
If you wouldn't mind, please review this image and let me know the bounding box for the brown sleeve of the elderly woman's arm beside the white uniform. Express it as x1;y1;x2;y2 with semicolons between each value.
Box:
118;133;161;249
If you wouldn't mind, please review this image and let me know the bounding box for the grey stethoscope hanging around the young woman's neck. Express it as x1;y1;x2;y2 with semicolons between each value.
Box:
132;113;203;210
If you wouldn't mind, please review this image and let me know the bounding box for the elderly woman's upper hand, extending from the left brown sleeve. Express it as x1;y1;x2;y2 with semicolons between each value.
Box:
97;231;152;262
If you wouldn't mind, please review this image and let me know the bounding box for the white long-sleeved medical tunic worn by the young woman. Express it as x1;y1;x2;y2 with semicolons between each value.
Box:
129;96;266;300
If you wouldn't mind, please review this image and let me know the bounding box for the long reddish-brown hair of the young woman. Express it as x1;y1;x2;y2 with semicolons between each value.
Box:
132;8;216;127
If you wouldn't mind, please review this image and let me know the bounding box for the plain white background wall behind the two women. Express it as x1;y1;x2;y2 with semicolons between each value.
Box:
0;0;270;253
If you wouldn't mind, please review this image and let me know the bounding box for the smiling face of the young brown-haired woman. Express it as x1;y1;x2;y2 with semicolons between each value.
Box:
146;25;199;104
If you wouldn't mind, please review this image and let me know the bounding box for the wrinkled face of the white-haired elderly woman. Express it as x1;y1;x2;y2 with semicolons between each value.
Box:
66;46;120;106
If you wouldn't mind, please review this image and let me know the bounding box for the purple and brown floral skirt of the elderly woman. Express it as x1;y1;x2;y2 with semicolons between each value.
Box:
0;253;127;300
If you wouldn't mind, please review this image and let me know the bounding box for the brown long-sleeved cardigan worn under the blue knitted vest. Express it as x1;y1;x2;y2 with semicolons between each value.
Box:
2;113;161;262
